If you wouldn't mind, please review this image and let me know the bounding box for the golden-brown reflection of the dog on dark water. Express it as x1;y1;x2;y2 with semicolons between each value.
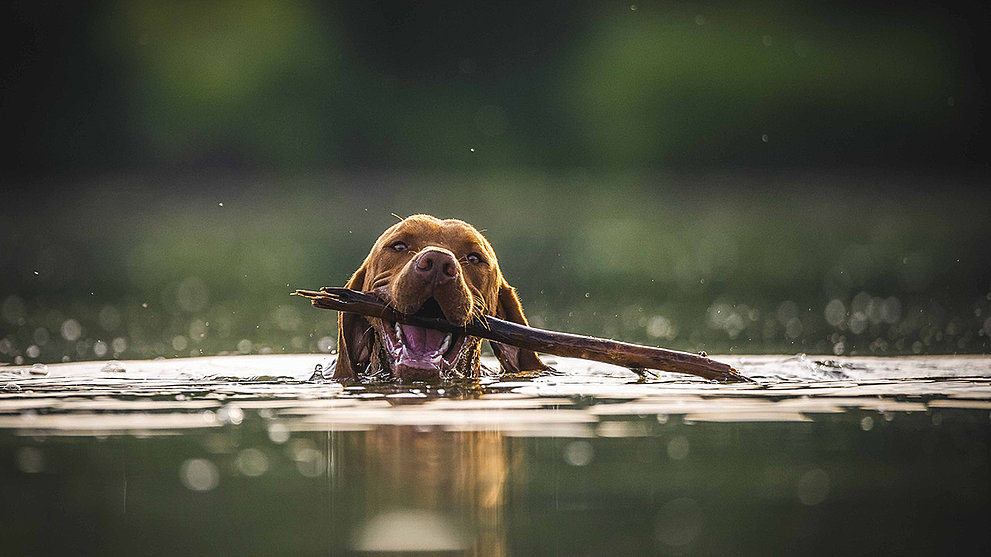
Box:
355;426;513;555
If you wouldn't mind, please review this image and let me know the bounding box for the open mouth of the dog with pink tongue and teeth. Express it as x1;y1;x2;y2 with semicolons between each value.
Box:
378;297;468;381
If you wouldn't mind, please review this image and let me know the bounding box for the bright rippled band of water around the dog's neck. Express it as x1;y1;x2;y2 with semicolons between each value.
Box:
0;355;991;436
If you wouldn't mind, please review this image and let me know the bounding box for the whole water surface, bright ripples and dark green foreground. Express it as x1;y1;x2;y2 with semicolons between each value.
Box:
0;355;991;555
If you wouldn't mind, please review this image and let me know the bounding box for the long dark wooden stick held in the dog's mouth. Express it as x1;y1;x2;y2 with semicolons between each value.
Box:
293;286;751;383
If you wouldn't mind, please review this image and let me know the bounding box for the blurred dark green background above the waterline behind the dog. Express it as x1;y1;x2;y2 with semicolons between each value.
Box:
0;2;991;363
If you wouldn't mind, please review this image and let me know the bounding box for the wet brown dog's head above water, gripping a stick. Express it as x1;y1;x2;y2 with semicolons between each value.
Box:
334;215;550;381
